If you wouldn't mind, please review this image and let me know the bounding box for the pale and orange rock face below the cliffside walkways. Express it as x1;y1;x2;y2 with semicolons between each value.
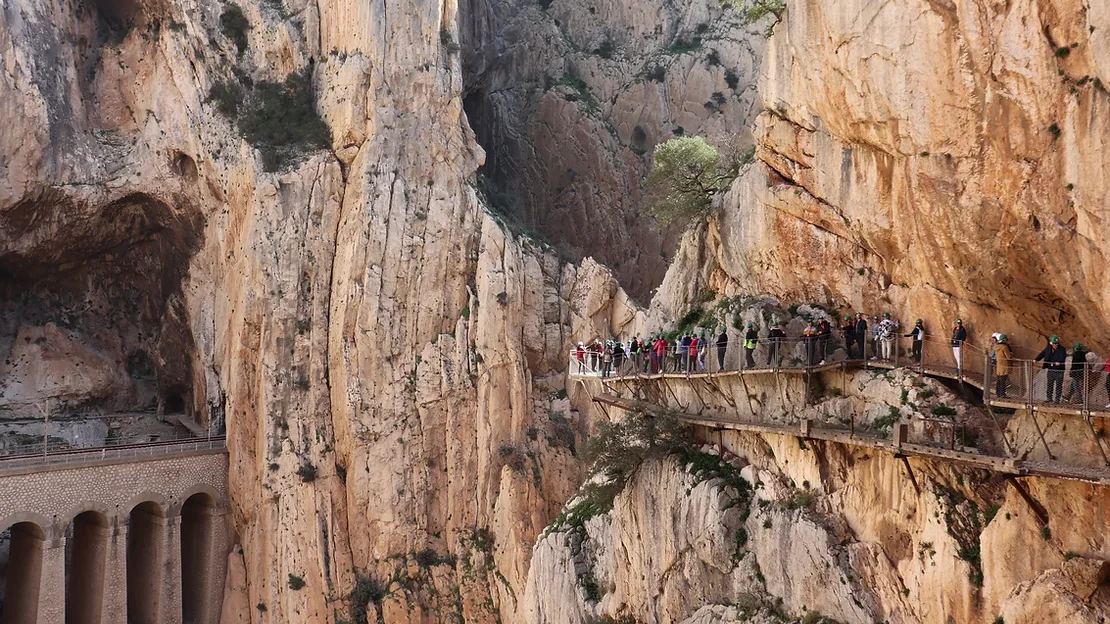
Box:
524;372;1110;624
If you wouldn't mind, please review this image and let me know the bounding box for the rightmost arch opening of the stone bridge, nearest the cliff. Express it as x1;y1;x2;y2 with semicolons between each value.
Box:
181;486;219;622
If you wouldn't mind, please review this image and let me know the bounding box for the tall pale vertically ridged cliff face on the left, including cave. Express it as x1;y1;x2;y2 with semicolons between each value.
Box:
0;0;635;622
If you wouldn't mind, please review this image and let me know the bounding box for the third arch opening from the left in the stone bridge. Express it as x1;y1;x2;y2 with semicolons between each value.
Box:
127;496;167;623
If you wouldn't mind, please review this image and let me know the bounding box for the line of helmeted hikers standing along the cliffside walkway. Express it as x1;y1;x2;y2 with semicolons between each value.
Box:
573;312;1110;409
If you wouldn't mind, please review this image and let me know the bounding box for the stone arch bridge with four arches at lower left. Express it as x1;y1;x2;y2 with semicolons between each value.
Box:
0;439;234;624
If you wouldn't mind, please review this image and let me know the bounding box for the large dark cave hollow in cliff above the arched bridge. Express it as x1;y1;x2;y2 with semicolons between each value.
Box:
0;194;203;430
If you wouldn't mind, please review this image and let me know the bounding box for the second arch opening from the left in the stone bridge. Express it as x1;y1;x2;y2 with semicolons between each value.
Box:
65;505;109;624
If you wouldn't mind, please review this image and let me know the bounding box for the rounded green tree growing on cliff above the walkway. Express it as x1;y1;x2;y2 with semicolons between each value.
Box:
646;137;739;225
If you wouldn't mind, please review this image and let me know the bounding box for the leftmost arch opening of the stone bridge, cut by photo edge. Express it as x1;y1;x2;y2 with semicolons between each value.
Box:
0;514;47;624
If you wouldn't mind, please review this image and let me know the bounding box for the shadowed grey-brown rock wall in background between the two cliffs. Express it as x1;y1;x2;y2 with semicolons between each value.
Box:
460;0;765;301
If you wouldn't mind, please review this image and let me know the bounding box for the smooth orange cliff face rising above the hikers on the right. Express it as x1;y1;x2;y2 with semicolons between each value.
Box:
660;0;1110;357
